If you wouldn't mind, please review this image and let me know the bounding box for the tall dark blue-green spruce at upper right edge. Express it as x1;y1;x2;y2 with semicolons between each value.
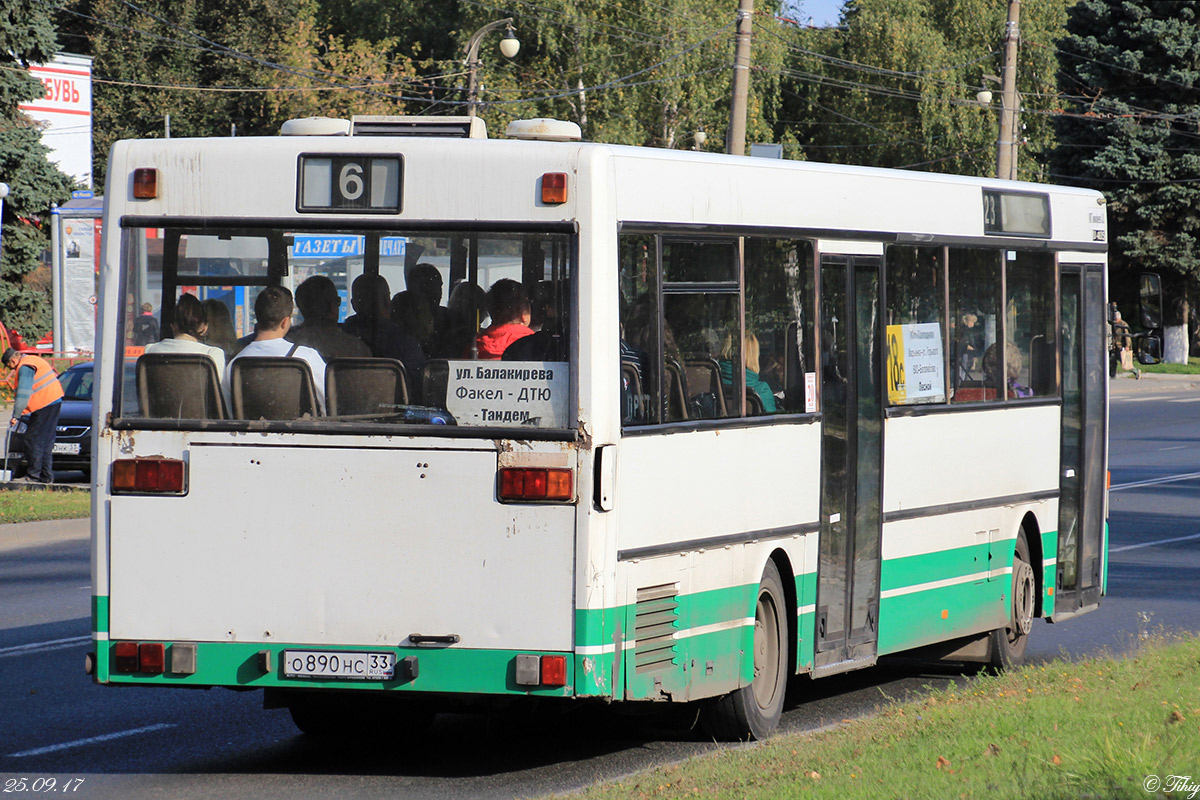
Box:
1054;0;1200;362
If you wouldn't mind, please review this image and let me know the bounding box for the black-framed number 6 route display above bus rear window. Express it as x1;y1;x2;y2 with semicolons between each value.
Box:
296;155;403;213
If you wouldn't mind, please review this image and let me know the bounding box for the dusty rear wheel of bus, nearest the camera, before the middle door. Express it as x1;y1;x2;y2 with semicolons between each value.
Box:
701;560;787;741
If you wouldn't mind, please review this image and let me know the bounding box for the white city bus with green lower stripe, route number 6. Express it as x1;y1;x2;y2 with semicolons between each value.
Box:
89;118;1108;739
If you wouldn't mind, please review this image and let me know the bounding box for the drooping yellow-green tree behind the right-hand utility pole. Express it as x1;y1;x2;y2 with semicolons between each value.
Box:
785;0;1074;180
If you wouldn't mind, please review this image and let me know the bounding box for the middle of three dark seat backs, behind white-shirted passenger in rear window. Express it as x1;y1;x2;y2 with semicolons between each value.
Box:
229;356;320;420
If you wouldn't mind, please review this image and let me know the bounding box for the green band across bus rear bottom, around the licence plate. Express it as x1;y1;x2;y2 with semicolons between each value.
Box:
103;642;575;697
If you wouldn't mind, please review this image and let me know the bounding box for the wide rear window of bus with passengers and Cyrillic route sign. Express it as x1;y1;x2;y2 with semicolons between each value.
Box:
115;228;575;429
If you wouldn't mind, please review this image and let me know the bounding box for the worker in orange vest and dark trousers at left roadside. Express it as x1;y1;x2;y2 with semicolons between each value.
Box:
0;348;62;483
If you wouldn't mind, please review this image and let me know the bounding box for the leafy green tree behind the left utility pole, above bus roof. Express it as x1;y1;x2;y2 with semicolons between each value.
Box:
460;0;786;150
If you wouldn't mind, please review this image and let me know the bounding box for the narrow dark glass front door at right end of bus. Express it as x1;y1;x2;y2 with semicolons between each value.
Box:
1054;264;1108;619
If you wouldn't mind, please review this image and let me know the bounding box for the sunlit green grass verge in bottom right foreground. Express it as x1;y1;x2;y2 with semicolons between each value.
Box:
583;639;1200;800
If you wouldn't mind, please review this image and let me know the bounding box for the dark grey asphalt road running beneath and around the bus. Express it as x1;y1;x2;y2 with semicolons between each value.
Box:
0;377;1200;799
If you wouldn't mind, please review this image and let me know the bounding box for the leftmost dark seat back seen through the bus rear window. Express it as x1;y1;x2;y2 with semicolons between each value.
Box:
136;353;229;420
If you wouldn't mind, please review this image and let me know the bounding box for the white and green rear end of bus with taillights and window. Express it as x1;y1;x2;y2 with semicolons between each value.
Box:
94;126;589;729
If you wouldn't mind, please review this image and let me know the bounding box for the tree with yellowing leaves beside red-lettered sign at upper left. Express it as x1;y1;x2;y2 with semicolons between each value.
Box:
61;0;415;184
